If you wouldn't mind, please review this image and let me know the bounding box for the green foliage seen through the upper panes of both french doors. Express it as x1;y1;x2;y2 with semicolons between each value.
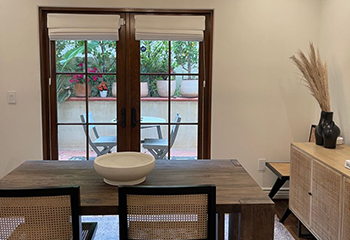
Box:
56;40;199;103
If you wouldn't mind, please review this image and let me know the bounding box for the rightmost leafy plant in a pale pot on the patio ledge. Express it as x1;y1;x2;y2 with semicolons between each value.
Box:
172;41;199;97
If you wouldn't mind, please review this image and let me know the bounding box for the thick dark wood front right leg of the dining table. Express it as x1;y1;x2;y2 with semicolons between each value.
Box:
240;203;274;240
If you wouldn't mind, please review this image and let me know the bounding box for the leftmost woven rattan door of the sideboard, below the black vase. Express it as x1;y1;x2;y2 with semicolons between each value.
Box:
289;147;312;226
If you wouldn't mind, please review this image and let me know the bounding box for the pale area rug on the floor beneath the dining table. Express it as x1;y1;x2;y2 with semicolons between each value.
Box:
82;216;294;240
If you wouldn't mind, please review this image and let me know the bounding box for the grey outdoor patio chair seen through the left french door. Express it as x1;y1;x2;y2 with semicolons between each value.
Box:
80;112;117;156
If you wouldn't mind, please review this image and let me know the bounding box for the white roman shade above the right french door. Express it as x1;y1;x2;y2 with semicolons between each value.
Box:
135;15;205;41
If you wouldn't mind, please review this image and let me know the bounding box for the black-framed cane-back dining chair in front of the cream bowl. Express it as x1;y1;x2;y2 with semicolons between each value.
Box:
118;185;216;240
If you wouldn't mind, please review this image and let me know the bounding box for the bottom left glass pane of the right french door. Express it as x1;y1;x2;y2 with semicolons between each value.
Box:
140;124;169;159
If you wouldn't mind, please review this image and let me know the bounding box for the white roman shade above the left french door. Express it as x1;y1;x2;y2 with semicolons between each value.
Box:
47;13;121;41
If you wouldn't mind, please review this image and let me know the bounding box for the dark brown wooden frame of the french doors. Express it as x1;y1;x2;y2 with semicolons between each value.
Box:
39;7;214;160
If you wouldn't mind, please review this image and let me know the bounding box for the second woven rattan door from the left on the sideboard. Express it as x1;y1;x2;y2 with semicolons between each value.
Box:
311;161;342;240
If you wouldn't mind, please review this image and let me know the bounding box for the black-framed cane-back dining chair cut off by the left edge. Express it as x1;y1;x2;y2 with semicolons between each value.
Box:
0;187;97;240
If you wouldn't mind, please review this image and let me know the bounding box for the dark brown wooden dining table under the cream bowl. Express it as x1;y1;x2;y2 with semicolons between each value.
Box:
0;159;274;240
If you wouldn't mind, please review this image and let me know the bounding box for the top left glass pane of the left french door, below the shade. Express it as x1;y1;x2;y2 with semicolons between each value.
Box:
56;40;85;73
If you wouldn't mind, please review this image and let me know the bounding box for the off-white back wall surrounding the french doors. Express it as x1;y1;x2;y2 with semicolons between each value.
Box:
0;0;320;187
